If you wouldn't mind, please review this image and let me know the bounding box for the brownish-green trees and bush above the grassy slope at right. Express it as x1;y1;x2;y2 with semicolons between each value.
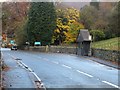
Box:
80;2;120;41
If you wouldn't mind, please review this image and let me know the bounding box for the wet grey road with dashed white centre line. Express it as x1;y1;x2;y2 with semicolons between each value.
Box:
2;50;119;88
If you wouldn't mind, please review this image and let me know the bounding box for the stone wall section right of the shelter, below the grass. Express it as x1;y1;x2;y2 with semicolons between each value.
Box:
92;48;120;62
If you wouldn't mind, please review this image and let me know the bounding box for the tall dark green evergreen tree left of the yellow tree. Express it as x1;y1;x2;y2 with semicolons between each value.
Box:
26;2;56;45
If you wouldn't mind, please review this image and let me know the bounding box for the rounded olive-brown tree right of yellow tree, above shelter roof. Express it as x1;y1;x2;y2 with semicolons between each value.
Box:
80;6;98;30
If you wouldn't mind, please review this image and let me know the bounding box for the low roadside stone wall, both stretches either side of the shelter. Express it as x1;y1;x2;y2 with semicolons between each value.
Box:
25;46;120;62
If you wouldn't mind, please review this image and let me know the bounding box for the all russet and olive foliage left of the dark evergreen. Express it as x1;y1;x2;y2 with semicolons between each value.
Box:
2;2;30;46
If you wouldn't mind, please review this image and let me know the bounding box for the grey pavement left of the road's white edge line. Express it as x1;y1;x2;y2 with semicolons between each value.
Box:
2;52;35;88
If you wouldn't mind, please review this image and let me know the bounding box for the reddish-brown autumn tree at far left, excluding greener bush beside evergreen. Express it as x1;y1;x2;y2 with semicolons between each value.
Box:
2;2;29;38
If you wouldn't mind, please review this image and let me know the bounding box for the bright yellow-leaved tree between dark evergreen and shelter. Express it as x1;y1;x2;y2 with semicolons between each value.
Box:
53;8;84;44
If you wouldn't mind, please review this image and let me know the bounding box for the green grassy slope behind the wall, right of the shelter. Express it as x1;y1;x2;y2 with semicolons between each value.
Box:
92;37;120;50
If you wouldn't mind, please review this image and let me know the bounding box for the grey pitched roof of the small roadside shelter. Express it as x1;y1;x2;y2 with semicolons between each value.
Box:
77;29;91;42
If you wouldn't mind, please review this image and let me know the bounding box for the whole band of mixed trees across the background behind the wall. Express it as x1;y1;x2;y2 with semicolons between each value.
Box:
2;2;120;45
